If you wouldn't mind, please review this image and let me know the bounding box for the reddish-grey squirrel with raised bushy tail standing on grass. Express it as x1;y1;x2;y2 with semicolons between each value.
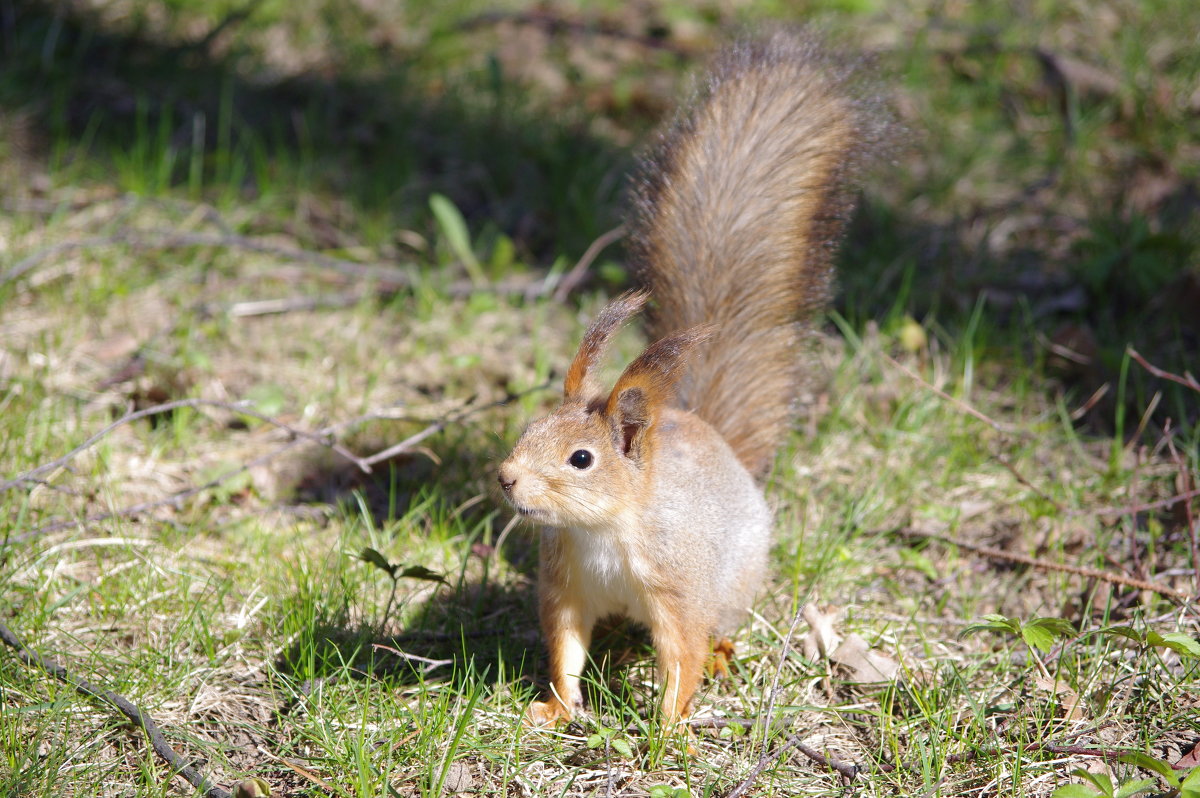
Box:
499;32;887;725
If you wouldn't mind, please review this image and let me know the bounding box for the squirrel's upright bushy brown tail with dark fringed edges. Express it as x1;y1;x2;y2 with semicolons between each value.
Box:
631;34;887;475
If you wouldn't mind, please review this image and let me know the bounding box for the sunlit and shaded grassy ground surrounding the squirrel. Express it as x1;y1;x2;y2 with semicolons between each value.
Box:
0;0;1200;798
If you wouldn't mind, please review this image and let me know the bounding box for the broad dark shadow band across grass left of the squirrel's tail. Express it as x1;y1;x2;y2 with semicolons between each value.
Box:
0;0;626;258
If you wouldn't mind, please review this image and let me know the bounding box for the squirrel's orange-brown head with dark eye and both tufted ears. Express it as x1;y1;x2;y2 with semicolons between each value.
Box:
499;292;709;528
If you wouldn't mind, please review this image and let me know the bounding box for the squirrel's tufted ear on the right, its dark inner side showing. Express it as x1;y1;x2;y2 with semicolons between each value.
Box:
605;325;713;455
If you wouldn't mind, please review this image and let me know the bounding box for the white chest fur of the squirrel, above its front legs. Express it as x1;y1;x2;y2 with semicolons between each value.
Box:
568;529;649;623
